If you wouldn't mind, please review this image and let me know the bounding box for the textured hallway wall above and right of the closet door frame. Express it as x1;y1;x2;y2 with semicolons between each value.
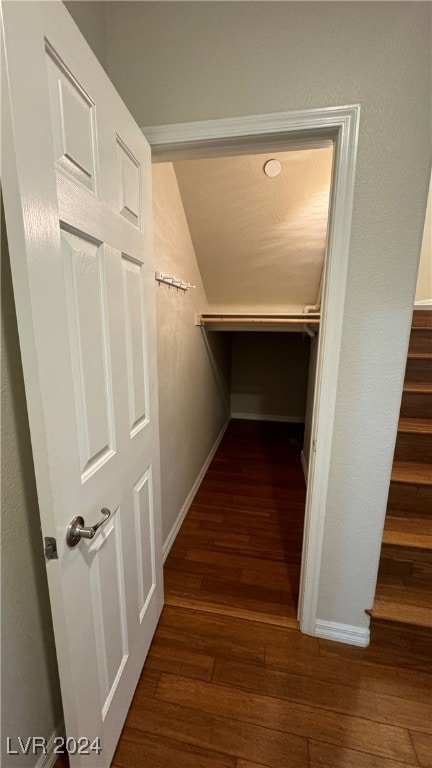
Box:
107;2;431;627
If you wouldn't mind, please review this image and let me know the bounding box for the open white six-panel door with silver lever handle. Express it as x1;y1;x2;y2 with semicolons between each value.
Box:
2;1;163;768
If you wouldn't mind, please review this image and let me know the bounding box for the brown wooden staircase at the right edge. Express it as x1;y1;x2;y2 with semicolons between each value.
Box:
368;310;432;636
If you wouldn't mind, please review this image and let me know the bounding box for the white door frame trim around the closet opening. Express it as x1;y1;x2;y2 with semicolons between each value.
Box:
142;104;360;635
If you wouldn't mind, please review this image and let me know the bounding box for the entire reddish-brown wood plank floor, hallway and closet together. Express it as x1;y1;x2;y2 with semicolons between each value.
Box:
112;421;432;768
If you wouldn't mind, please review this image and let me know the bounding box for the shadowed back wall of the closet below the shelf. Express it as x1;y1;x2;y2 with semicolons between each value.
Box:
231;332;309;421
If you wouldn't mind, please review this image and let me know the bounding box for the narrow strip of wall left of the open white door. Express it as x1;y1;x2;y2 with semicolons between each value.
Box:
1;206;62;768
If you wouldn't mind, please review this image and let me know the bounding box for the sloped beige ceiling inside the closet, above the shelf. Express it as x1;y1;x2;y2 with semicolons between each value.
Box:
174;146;333;312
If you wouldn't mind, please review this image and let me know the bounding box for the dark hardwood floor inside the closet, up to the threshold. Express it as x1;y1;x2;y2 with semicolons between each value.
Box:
165;421;306;628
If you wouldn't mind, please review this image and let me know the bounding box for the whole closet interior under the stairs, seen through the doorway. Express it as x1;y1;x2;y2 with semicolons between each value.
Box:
153;141;333;623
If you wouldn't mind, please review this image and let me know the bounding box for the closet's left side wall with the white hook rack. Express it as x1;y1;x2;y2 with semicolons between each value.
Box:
153;163;230;542
